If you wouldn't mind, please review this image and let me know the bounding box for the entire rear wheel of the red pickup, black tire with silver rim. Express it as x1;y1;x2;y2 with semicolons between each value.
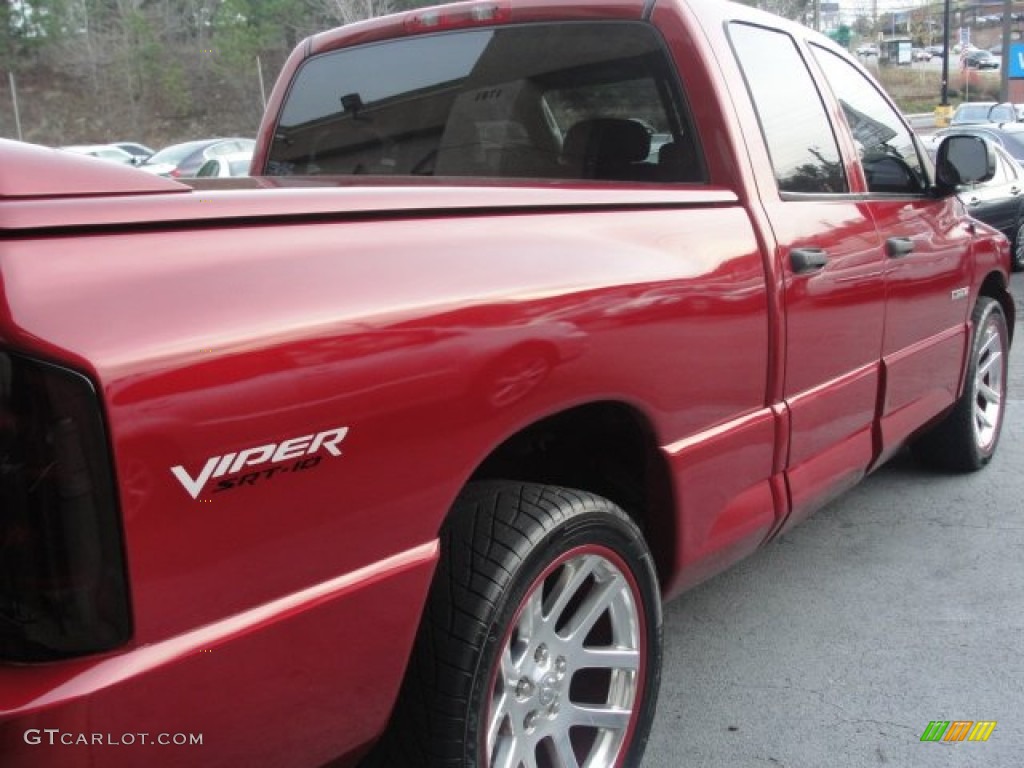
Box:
366;481;662;768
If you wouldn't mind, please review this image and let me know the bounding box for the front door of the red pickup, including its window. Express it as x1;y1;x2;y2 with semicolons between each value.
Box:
811;45;974;461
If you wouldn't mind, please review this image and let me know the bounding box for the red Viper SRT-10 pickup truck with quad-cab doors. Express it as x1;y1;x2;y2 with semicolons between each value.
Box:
0;0;1014;768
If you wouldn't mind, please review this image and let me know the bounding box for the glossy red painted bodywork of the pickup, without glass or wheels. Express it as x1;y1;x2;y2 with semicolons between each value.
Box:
0;0;1009;766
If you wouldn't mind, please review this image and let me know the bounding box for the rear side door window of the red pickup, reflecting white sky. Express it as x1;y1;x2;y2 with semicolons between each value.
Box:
729;24;849;195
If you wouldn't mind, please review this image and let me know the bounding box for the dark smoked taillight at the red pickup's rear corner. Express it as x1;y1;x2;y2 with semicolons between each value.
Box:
0;352;131;662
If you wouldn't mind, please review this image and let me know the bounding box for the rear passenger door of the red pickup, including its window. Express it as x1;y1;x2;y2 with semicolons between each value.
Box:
730;24;886;525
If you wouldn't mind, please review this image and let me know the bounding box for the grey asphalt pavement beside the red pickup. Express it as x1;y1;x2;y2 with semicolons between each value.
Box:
644;274;1024;768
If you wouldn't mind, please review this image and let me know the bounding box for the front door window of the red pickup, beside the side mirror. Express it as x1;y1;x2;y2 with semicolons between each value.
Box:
811;46;928;195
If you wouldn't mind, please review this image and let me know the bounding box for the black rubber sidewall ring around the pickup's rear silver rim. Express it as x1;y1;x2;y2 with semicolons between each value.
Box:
465;503;662;768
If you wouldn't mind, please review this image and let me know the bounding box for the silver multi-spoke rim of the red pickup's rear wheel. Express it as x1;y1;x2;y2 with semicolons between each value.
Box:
486;552;643;768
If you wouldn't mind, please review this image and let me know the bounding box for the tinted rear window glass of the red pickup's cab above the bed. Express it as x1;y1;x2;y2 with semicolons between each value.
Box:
266;23;703;182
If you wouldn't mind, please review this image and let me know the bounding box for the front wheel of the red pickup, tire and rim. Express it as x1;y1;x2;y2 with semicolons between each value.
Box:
911;296;1010;472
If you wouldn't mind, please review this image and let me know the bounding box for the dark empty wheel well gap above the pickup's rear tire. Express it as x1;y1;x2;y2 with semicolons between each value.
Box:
470;402;676;585
